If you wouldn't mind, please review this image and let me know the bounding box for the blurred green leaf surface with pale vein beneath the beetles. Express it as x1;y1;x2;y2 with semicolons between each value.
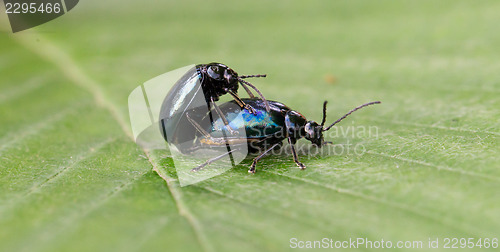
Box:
0;0;500;251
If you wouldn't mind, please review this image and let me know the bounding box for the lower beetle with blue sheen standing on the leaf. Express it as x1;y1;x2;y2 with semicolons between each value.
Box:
187;98;380;173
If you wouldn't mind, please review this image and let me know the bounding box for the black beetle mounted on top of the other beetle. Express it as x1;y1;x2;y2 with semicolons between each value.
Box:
159;62;270;148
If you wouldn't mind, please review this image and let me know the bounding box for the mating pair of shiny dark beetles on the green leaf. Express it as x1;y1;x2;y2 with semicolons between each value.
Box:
160;63;380;173
